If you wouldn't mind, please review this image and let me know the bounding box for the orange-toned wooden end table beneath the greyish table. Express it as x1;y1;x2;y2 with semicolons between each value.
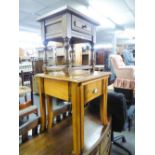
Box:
37;71;109;155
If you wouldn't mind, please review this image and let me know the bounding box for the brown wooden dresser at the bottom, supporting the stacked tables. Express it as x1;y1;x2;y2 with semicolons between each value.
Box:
19;114;111;155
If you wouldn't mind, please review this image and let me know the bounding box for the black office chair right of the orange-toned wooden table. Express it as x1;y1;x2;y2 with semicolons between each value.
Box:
108;92;134;155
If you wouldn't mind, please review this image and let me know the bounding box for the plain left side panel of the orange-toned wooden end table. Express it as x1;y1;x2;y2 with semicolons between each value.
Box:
44;79;69;101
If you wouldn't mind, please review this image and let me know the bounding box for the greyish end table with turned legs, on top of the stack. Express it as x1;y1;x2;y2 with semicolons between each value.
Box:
38;6;98;74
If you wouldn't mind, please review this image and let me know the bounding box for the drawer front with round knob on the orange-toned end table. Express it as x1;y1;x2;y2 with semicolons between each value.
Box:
84;80;102;103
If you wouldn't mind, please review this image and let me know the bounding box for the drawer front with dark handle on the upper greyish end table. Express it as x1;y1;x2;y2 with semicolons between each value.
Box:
72;15;92;35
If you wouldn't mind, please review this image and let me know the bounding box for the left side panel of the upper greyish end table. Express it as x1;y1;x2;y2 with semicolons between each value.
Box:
45;17;63;39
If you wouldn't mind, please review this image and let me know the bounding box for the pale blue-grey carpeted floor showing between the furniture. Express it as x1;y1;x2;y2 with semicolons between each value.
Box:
20;92;135;155
